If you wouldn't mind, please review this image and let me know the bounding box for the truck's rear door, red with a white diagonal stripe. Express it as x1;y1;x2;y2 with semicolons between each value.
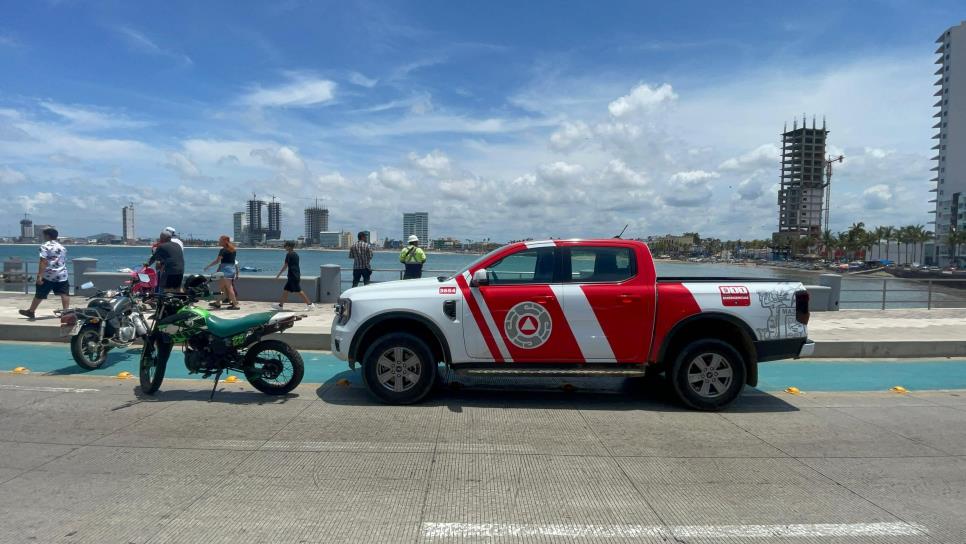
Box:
554;245;655;363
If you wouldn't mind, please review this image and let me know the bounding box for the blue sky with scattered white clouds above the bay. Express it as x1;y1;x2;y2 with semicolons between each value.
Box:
0;0;966;241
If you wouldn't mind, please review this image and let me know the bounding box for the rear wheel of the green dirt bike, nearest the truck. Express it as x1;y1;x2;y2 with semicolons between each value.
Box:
244;340;305;395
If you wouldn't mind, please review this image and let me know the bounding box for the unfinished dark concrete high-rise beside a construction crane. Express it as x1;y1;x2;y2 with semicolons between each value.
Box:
774;117;829;246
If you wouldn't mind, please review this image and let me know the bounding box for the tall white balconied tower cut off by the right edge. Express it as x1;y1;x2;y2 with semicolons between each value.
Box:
930;21;966;266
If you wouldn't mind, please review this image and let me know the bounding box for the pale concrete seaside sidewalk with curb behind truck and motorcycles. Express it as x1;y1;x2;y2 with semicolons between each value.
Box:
0;293;966;359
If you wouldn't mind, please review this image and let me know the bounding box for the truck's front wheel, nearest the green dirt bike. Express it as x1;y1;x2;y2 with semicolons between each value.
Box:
362;333;439;404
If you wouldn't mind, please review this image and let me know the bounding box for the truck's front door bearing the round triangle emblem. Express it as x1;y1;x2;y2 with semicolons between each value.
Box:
463;245;580;363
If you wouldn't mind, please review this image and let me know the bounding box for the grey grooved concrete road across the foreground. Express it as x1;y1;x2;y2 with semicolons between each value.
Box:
0;373;966;544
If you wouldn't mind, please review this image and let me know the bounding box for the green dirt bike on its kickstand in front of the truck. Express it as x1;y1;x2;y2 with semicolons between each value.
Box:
140;274;305;399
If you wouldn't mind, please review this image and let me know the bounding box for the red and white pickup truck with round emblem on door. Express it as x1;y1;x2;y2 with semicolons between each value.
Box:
332;239;814;410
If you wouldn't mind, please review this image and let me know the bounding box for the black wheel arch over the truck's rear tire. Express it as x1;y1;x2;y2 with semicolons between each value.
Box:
657;312;758;387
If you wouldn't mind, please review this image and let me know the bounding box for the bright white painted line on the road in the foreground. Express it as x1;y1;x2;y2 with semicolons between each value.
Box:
423;522;929;538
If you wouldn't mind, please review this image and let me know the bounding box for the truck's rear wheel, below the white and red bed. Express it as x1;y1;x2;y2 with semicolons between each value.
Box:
668;339;746;411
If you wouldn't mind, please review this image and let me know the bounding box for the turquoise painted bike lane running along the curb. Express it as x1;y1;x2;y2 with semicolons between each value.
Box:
0;342;966;391
